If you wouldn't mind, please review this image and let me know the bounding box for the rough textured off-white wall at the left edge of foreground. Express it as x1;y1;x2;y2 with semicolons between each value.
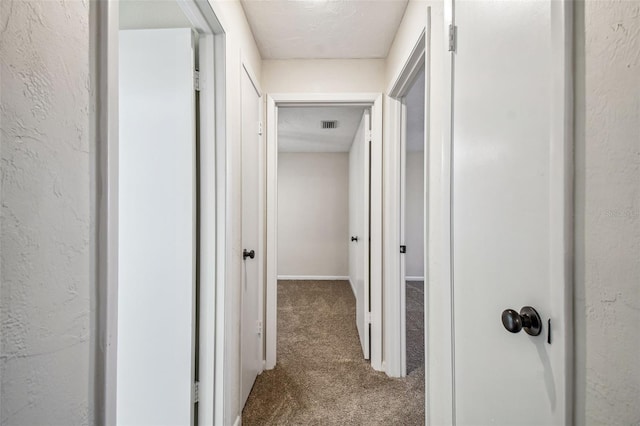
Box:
0;0;91;425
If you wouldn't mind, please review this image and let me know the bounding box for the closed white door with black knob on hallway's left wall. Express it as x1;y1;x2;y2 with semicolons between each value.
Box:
240;65;263;406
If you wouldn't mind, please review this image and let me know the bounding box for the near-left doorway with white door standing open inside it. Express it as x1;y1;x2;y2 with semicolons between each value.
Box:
98;0;224;424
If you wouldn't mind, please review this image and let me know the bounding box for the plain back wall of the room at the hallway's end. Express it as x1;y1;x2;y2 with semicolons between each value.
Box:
278;152;349;277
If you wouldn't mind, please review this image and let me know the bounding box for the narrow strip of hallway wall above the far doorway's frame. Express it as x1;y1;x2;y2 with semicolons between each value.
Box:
262;59;385;93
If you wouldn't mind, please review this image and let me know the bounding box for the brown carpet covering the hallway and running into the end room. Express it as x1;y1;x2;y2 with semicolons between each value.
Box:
242;281;424;426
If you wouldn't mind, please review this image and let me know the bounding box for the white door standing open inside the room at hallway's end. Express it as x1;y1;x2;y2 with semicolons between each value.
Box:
349;111;371;359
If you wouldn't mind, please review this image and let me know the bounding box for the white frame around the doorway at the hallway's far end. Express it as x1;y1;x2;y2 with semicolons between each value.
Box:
265;93;384;371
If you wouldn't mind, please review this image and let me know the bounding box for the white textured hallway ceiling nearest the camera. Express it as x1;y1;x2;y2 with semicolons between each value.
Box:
242;0;408;59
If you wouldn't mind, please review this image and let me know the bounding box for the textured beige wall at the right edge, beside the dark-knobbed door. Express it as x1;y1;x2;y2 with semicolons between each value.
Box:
575;1;640;425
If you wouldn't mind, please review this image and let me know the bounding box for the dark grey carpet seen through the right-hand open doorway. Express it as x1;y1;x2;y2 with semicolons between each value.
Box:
405;281;424;374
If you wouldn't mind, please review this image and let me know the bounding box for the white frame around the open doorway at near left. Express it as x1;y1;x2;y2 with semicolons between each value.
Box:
92;0;226;425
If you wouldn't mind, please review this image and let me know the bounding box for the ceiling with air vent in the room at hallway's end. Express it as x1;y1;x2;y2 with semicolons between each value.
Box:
278;106;365;152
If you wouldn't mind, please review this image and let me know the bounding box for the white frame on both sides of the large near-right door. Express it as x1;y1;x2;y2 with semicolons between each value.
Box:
425;0;573;425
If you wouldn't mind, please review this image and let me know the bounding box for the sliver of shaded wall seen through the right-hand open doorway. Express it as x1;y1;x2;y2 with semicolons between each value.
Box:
405;151;424;278
